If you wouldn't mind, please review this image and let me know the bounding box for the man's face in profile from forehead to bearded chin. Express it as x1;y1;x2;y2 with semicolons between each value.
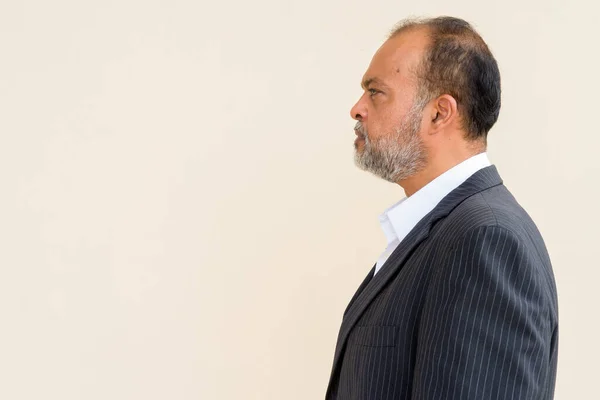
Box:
350;29;428;183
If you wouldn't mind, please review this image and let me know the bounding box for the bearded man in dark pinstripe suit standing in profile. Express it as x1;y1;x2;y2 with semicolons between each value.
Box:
326;17;558;400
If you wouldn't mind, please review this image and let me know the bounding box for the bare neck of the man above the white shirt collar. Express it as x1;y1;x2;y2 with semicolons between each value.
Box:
398;149;485;197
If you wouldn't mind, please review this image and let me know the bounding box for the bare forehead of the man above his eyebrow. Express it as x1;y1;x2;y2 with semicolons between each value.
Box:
363;28;429;85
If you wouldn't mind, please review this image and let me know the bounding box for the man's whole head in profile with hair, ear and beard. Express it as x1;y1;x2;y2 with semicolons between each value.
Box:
351;17;500;188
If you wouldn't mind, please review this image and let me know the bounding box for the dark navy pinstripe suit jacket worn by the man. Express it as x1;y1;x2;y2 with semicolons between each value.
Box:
326;166;558;400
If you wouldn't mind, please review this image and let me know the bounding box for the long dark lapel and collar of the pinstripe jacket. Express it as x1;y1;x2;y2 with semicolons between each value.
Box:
330;165;502;385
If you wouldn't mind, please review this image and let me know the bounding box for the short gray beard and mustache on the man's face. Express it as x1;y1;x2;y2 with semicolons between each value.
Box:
354;107;427;183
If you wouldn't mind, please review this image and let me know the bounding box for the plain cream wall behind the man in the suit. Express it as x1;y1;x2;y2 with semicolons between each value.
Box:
0;0;600;400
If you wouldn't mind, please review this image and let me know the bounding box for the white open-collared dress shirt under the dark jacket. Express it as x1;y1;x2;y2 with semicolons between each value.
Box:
375;153;491;273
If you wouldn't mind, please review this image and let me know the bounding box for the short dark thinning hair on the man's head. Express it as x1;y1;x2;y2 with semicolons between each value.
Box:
388;17;500;142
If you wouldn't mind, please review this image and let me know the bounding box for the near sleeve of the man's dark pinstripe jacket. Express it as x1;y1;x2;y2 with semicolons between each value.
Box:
412;226;552;400
